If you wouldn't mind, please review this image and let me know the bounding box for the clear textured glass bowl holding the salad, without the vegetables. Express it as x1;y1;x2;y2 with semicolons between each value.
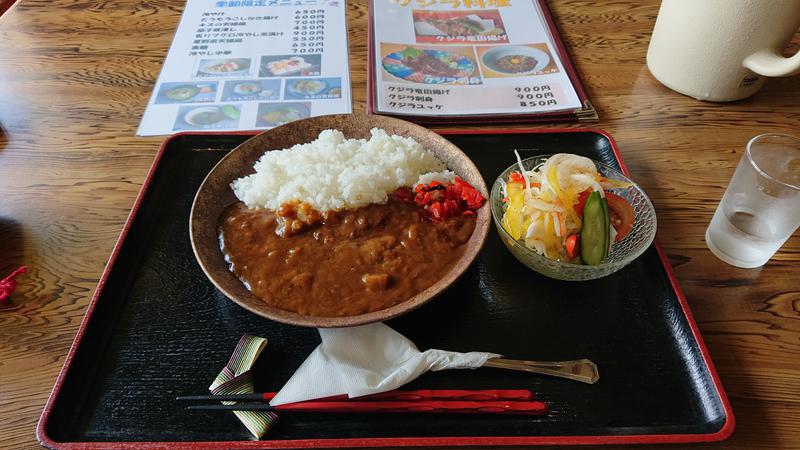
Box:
489;155;656;281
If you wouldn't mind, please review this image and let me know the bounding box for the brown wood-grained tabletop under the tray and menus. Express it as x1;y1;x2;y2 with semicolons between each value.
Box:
0;0;800;449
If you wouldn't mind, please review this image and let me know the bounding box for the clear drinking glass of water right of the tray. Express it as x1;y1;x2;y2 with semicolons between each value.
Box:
706;134;800;268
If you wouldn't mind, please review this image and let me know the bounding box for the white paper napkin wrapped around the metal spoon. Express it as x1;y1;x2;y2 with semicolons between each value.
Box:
269;323;500;406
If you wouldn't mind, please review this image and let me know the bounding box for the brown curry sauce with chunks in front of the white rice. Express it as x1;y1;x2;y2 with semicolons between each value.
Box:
219;198;475;317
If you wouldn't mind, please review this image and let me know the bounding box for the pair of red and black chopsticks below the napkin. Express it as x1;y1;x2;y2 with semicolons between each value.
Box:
177;389;547;415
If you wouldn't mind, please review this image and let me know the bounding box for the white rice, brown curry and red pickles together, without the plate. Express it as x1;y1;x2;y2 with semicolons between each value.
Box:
223;128;486;317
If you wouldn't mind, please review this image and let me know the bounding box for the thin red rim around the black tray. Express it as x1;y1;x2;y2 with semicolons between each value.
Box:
36;128;736;450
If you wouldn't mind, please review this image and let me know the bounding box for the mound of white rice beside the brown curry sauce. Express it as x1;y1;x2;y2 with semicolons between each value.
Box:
231;128;454;211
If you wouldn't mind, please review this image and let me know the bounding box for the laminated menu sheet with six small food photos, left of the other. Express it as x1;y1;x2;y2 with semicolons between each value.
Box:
137;0;352;136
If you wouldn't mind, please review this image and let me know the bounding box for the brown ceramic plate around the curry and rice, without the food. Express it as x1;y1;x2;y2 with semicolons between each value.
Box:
189;114;491;328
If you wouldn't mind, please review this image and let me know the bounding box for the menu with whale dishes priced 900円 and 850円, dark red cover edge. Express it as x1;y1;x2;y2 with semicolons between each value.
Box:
367;0;597;123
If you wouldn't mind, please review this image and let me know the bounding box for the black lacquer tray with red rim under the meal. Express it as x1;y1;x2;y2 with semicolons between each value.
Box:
37;130;734;448
